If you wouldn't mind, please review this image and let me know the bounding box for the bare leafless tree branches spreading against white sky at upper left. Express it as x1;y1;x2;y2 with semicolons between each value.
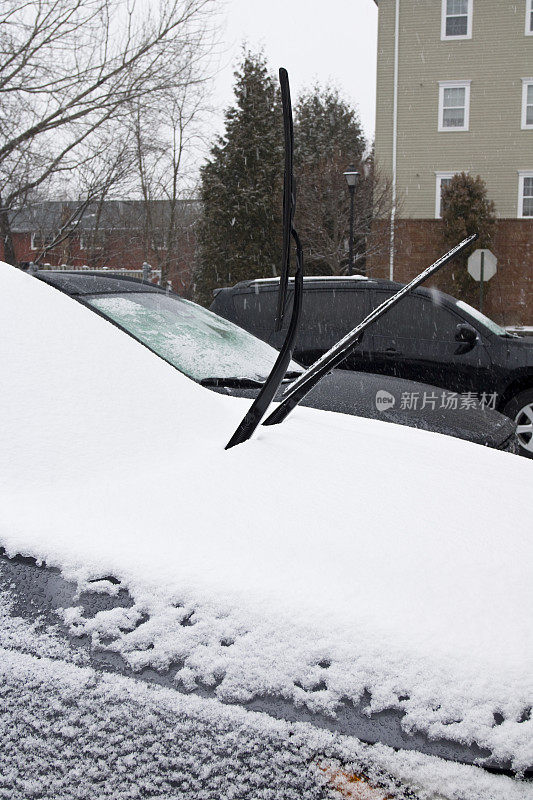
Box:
0;0;215;266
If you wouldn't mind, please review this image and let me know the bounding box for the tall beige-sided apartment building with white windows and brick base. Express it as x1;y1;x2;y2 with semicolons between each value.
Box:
370;0;533;324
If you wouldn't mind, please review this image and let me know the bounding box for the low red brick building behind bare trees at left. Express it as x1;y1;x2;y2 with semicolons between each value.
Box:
0;200;199;295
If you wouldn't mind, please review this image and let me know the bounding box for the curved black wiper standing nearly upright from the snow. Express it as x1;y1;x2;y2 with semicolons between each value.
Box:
226;67;304;450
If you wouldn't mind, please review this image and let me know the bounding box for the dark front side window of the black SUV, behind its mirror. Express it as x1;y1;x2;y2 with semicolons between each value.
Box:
372;292;461;341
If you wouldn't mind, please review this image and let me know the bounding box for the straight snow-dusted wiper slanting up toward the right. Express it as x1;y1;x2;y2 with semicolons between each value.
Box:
263;233;478;425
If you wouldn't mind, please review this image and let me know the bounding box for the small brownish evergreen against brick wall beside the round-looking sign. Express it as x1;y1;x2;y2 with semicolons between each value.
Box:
441;172;496;303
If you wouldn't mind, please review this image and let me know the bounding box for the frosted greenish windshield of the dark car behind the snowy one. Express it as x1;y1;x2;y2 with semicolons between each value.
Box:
85;292;301;381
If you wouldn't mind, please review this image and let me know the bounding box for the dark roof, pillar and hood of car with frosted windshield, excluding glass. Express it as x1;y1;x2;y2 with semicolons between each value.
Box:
36;270;517;452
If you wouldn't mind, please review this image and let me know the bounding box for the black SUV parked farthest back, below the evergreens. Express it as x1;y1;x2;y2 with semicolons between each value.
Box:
211;276;533;458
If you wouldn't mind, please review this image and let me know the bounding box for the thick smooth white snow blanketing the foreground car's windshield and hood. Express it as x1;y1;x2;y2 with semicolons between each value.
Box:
0;265;533;769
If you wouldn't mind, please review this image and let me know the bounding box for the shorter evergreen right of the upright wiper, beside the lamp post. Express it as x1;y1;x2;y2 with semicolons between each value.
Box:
295;86;373;274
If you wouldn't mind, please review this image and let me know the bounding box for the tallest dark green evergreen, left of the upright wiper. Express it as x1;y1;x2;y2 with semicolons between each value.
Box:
195;52;283;305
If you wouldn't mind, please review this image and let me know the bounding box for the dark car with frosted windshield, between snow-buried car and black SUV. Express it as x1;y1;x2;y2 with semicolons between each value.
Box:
29;270;517;453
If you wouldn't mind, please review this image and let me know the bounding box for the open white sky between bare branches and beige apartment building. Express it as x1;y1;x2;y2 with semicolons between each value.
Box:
208;0;377;144
